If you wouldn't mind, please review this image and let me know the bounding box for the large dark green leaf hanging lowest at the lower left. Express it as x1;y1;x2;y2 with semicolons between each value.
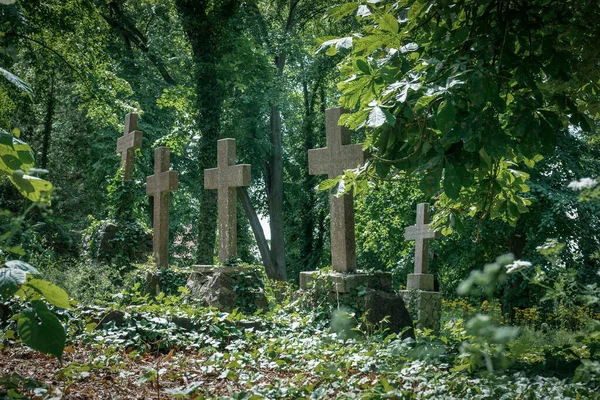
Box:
17;300;66;362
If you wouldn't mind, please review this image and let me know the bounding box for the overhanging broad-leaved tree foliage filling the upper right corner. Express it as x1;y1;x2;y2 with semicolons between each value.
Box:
319;0;600;234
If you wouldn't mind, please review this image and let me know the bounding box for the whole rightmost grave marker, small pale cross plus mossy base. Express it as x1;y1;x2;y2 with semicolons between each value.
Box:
401;203;442;332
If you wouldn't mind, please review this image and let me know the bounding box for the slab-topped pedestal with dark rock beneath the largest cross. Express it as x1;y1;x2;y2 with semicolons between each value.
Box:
300;271;414;337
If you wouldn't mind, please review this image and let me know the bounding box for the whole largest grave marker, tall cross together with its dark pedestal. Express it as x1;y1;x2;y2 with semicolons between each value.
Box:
300;108;413;336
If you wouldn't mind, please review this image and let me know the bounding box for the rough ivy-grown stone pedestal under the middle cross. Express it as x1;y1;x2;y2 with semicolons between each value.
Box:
185;265;268;312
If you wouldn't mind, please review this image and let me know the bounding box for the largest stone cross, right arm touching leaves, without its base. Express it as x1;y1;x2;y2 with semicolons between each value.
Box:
308;108;365;272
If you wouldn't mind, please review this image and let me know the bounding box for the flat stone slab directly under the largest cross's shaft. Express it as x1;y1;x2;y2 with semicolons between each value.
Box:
300;271;393;293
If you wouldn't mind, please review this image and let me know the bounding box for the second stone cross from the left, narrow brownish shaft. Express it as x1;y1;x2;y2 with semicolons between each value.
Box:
146;147;179;267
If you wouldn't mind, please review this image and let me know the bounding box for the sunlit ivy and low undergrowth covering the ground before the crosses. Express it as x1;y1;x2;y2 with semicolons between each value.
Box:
0;262;600;399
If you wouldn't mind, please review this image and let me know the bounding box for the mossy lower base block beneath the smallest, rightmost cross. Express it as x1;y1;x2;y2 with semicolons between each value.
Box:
400;290;442;332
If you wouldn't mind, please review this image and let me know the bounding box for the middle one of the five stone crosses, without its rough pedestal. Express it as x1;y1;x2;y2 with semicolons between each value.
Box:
204;139;250;264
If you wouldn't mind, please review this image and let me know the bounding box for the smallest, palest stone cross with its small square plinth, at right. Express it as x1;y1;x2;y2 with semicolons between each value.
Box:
404;203;440;291
